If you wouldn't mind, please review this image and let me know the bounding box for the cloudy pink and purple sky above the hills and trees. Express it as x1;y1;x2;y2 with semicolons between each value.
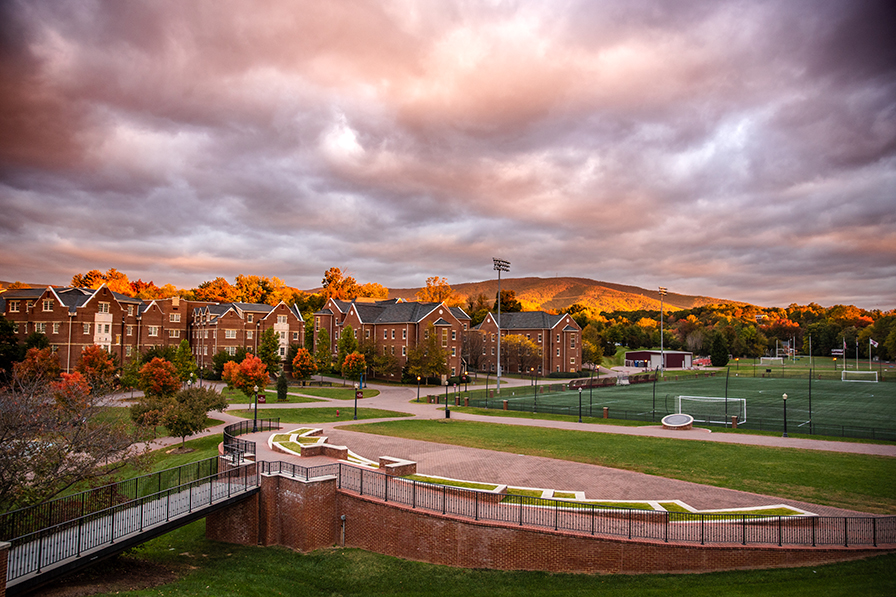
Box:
0;0;896;310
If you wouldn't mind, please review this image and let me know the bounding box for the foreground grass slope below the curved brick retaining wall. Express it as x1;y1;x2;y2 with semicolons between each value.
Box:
63;521;896;597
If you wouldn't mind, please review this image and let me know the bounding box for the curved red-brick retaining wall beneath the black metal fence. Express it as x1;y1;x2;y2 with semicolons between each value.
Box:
206;475;892;574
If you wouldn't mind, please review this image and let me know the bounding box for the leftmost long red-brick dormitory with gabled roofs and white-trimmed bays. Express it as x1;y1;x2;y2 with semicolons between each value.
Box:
0;285;305;372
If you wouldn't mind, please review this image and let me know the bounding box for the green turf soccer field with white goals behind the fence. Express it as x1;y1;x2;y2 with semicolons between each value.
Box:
480;374;896;440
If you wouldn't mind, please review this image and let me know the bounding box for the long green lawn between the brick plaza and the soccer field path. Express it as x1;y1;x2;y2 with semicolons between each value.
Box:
352;419;896;514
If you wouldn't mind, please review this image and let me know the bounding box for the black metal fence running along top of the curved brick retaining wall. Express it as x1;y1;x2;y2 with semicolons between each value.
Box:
326;463;896;547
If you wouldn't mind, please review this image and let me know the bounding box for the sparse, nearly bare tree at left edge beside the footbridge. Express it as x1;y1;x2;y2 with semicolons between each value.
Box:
0;358;139;512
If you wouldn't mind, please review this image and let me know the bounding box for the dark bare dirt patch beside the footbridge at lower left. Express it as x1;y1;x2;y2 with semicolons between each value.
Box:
27;556;187;597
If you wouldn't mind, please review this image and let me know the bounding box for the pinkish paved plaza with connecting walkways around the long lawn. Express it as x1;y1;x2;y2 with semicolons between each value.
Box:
121;380;896;516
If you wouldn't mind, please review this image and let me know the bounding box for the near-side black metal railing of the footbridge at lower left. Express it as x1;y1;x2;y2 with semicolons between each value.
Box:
6;457;258;585
